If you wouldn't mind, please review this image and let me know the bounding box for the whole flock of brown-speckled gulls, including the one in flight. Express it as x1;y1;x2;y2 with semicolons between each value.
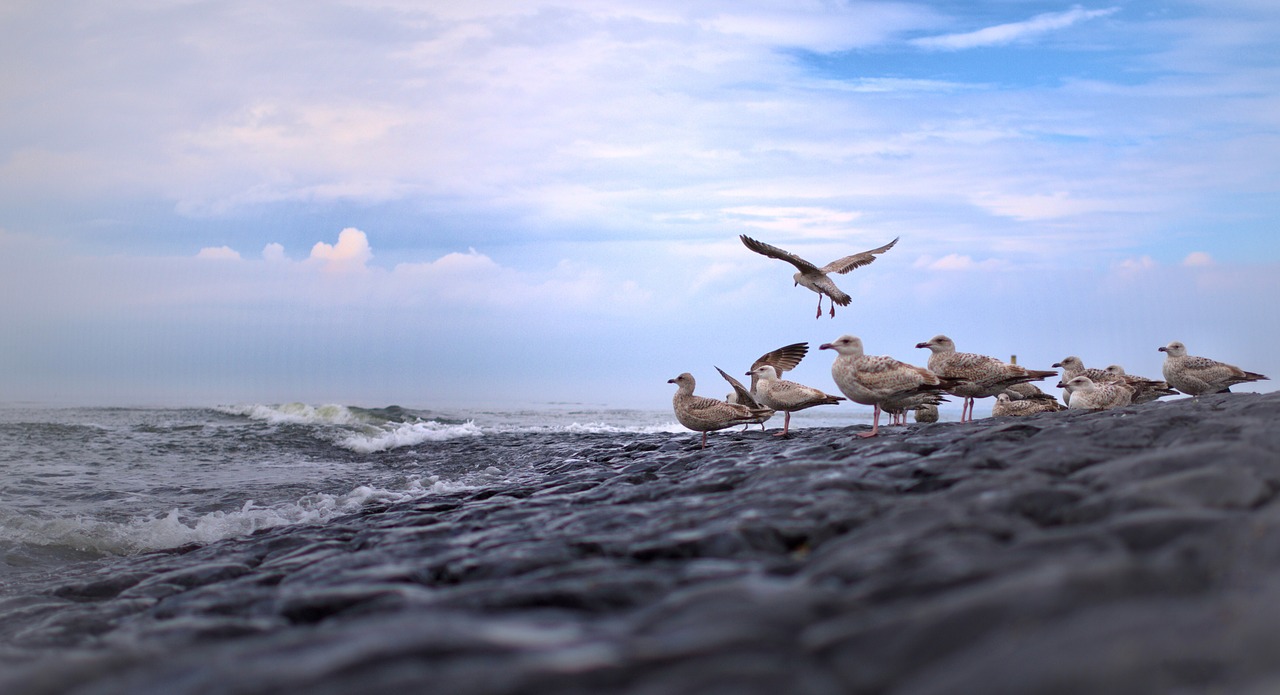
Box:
668;236;1267;448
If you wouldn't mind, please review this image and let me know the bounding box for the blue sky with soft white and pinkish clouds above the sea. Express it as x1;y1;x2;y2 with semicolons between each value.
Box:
0;0;1280;409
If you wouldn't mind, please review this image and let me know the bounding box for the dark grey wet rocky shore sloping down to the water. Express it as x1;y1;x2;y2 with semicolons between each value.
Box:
0;393;1280;695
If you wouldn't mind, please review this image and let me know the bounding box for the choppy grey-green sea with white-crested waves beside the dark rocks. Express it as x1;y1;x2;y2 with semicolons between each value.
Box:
0;403;870;595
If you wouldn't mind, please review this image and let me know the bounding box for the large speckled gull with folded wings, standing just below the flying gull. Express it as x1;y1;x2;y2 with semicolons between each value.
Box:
818;335;956;436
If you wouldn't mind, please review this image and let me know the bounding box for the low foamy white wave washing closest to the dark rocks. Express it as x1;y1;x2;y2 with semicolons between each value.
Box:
0;476;472;555
